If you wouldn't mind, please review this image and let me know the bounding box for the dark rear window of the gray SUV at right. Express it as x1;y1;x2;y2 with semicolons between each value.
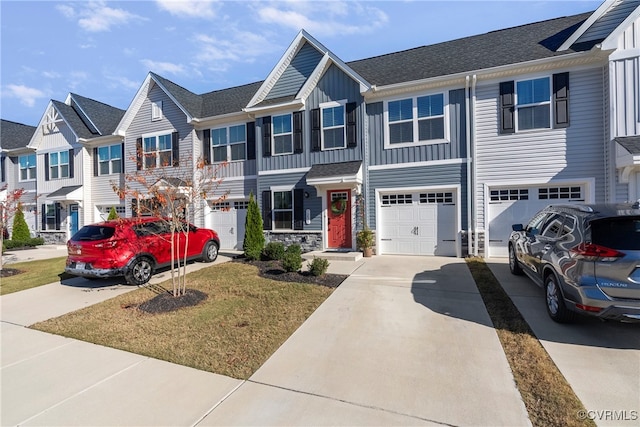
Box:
591;217;640;251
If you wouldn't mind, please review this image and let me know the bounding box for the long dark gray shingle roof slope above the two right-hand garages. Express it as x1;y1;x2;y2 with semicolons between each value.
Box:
347;13;596;86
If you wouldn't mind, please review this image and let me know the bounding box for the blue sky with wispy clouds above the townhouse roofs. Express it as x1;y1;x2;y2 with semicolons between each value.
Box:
0;0;602;126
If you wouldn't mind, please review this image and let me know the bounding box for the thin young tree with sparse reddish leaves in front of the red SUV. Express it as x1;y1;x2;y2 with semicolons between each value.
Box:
112;155;228;296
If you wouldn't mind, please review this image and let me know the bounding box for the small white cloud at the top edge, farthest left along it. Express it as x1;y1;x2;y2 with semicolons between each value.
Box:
56;1;146;33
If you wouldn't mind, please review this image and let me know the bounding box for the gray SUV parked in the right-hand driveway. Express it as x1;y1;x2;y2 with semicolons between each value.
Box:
509;203;640;322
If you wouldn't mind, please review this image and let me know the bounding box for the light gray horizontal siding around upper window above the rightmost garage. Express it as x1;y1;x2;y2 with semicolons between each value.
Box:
475;68;607;229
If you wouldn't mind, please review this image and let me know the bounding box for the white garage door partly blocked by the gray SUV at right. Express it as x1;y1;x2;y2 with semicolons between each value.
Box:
486;185;585;257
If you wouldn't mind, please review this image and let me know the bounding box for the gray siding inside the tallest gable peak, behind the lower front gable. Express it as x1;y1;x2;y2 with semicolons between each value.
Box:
265;43;322;99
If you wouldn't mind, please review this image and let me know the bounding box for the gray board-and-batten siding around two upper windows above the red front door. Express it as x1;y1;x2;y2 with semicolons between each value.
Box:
256;66;364;171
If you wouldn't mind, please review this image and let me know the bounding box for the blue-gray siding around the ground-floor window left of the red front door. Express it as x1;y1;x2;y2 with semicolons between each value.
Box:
257;172;322;231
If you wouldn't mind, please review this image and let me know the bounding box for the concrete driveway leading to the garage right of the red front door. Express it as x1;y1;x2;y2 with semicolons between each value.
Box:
199;256;530;426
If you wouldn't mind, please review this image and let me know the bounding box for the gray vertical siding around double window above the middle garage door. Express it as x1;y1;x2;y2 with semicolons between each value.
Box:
367;89;467;165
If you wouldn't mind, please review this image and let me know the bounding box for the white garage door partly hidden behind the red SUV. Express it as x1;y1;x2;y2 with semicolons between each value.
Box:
205;201;249;251
